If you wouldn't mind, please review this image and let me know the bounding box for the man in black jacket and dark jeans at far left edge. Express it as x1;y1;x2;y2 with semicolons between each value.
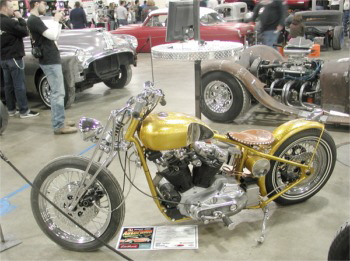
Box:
0;0;39;119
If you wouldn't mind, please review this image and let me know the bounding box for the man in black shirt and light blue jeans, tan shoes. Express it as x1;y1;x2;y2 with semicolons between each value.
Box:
28;0;77;134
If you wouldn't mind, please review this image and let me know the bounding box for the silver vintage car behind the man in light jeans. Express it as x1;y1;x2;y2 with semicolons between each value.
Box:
2;17;137;107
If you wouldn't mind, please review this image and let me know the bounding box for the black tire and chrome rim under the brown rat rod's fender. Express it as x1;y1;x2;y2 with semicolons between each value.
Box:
201;71;250;122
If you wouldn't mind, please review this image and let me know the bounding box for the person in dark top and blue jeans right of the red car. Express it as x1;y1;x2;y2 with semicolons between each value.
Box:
252;0;286;47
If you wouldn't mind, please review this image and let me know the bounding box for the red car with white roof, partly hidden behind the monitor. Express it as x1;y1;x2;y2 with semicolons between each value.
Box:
111;7;254;53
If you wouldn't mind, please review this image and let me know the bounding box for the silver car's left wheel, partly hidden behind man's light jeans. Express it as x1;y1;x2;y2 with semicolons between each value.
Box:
37;73;75;108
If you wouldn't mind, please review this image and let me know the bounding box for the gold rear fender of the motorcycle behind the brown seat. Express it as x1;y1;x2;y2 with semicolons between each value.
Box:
258;119;324;196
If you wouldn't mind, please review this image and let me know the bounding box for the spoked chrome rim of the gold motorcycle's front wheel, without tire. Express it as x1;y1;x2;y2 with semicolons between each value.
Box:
39;168;111;244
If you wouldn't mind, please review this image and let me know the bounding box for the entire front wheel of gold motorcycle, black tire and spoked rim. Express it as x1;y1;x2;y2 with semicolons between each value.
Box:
31;156;125;251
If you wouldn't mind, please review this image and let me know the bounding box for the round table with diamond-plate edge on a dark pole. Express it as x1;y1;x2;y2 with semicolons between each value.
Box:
151;41;244;119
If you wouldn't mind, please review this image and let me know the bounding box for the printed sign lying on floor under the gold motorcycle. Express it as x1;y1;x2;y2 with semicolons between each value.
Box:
117;226;198;250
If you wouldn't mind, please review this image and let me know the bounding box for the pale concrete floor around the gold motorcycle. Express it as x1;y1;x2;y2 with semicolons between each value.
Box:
0;42;350;260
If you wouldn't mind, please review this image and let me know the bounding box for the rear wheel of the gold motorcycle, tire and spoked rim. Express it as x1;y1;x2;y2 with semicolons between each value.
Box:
265;129;337;205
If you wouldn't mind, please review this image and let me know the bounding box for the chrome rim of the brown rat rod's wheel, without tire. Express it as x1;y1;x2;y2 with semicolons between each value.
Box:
203;81;233;113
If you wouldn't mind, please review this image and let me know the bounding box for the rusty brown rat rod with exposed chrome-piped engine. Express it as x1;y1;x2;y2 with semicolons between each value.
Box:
201;37;350;125
